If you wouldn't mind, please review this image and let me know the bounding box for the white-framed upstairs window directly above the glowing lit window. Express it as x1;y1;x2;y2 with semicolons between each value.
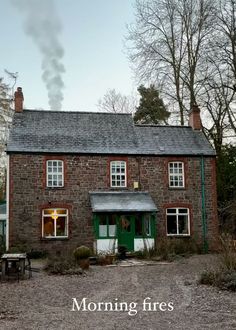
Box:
47;160;64;188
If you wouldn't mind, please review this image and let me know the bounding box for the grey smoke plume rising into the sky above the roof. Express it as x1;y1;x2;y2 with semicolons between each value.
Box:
12;0;65;110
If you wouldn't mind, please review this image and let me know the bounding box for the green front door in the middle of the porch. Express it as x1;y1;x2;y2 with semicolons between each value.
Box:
118;215;134;251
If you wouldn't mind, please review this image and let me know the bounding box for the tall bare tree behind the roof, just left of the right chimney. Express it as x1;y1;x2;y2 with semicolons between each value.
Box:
127;0;215;125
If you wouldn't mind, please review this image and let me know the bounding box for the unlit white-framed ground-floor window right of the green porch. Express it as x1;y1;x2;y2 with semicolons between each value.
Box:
166;207;190;236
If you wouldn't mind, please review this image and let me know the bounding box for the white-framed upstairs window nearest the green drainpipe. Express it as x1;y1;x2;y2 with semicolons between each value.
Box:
168;162;184;188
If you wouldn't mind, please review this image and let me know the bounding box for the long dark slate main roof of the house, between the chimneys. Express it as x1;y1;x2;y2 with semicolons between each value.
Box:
7;110;215;155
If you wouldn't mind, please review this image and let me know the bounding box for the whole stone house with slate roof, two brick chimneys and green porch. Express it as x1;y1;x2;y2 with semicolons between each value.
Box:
7;88;218;252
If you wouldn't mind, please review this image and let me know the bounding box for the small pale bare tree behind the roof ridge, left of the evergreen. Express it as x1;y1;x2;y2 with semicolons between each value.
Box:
97;89;137;113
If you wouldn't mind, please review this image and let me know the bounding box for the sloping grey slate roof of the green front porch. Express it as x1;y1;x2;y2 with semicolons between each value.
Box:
90;191;157;212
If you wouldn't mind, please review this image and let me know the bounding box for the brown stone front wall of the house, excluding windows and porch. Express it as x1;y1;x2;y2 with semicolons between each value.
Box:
9;154;218;251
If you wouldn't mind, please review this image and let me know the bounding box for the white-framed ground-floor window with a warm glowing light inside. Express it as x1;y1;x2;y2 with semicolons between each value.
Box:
42;208;68;238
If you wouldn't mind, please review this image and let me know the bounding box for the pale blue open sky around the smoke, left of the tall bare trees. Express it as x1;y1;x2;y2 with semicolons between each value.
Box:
0;0;137;111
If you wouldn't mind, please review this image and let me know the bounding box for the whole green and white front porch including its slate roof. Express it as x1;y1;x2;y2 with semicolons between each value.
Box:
90;192;157;253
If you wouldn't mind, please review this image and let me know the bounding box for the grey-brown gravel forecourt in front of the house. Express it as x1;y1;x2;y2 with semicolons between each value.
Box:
0;255;236;330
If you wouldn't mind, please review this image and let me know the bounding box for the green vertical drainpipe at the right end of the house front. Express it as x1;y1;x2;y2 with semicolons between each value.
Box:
201;155;208;253
